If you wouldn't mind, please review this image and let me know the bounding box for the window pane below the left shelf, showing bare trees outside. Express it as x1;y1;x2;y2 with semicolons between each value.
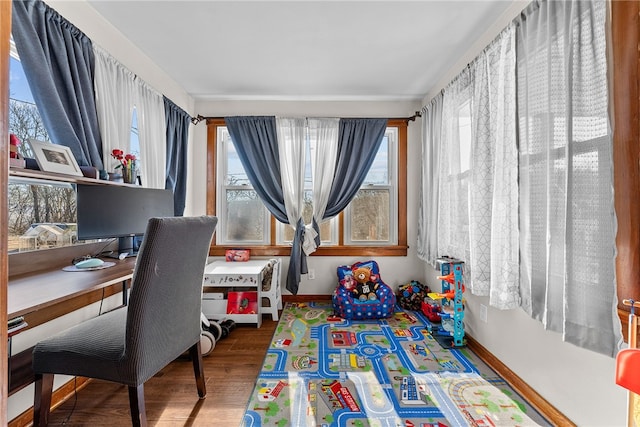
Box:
8;179;77;252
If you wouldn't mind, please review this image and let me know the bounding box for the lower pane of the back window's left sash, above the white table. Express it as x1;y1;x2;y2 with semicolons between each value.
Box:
224;189;265;242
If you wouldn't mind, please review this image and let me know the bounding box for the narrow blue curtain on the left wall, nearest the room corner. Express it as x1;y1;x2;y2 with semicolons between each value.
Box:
163;96;191;216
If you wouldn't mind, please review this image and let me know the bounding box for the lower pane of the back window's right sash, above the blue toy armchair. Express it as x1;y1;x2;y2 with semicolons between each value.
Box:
349;189;390;242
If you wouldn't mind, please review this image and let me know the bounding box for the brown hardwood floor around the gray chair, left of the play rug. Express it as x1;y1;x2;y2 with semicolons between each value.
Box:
42;316;277;427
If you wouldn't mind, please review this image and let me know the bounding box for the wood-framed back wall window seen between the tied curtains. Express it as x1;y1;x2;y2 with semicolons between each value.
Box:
207;119;407;255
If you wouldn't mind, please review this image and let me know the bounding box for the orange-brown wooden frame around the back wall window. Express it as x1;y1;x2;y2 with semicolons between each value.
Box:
206;118;408;256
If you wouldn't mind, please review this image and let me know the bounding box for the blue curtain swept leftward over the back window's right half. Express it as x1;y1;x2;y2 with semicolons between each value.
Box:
324;119;387;218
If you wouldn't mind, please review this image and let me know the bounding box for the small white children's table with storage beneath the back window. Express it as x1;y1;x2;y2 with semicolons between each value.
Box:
202;259;269;328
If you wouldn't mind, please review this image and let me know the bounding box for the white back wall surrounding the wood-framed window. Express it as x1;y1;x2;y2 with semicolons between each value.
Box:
186;101;424;295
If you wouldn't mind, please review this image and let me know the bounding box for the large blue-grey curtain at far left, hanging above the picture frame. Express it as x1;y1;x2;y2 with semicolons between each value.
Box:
12;0;104;169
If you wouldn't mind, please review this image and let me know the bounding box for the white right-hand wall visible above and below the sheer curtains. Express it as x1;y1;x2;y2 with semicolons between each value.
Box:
423;1;626;427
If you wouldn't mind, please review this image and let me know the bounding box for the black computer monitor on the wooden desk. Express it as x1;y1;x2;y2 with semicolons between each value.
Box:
76;184;174;257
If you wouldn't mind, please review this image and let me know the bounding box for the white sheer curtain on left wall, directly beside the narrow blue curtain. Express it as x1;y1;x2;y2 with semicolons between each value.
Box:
135;78;167;188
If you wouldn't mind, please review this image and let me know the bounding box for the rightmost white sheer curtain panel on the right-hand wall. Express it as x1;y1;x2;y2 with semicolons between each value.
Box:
517;1;622;356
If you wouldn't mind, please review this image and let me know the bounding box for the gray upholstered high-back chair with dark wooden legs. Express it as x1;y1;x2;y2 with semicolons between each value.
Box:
33;216;218;426
